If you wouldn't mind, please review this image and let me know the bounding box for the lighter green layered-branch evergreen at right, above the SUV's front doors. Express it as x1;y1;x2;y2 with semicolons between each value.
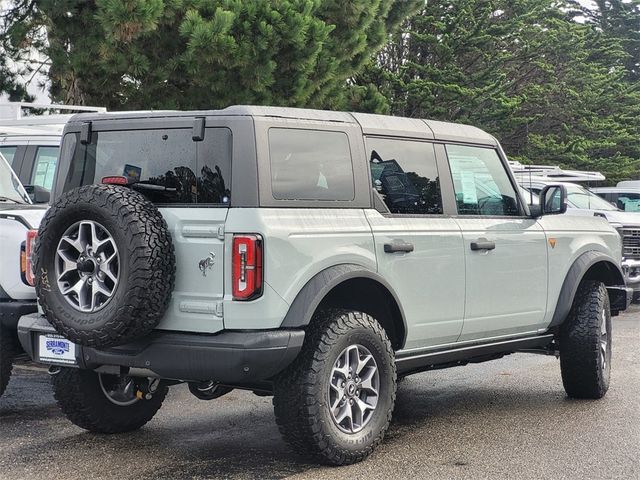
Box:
356;0;640;181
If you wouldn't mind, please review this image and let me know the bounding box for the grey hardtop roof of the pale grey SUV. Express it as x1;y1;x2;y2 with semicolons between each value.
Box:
69;105;498;146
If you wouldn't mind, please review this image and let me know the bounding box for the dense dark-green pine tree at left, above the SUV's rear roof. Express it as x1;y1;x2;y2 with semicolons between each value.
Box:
5;0;422;109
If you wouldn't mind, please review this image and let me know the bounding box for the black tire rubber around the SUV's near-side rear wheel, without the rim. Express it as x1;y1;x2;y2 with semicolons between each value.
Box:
273;310;396;465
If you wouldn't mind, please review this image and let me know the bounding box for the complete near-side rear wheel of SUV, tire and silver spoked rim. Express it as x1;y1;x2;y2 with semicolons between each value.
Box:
273;310;396;465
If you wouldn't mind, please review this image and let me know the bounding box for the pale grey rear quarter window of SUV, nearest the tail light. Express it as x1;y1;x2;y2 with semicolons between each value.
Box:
269;128;355;201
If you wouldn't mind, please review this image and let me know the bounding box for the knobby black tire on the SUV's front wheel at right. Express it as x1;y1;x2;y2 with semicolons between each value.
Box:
559;280;611;399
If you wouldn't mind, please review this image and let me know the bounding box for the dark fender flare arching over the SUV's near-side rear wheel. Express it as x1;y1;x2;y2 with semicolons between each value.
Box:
281;263;407;345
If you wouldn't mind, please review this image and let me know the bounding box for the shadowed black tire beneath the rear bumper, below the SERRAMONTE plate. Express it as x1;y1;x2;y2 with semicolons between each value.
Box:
52;368;169;434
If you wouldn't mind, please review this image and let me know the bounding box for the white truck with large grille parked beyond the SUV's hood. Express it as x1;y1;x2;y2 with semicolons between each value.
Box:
520;178;640;298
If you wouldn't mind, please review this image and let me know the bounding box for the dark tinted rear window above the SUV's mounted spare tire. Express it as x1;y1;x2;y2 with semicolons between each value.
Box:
63;128;232;204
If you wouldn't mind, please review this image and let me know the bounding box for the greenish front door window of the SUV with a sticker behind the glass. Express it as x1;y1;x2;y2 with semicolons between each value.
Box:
446;145;520;216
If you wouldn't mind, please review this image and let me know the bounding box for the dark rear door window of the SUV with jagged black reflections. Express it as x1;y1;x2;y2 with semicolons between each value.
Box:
367;138;442;215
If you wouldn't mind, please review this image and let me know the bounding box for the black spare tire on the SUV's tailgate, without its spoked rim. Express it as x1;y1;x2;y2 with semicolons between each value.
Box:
35;185;175;348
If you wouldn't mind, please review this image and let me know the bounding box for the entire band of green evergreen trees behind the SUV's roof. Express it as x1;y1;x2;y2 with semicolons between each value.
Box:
0;0;640;182
